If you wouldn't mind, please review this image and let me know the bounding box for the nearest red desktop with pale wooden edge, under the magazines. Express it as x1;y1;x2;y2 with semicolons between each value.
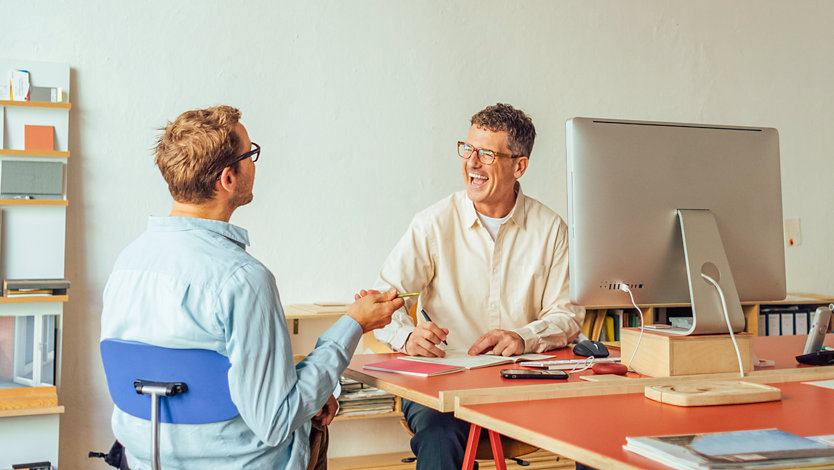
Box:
455;382;834;469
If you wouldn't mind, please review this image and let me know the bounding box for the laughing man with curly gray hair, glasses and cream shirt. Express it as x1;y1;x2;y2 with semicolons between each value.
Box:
368;103;585;470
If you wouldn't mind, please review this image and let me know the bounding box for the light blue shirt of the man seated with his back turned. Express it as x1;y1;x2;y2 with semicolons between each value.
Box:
101;217;362;470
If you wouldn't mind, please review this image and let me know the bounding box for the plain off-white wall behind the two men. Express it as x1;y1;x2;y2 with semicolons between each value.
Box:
0;0;834;468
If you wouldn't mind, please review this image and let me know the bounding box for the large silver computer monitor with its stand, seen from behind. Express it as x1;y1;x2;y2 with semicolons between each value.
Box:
567;118;785;334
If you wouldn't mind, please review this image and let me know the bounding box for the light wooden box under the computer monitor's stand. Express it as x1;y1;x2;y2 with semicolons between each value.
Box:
620;328;753;377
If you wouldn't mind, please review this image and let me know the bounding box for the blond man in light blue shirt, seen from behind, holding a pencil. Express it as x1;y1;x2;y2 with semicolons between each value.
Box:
101;106;402;470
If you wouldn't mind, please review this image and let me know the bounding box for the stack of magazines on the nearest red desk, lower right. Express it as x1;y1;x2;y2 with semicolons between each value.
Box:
623;429;834;469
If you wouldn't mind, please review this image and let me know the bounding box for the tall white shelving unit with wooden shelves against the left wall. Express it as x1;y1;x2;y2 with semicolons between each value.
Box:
0;59;72;469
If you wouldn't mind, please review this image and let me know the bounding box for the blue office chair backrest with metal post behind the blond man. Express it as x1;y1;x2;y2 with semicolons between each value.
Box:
101;339;239;470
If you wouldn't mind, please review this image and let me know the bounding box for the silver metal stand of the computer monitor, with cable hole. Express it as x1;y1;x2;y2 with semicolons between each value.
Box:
667;209;744;335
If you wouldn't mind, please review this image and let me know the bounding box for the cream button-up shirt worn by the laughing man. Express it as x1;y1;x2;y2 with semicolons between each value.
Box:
374;186;585;352
